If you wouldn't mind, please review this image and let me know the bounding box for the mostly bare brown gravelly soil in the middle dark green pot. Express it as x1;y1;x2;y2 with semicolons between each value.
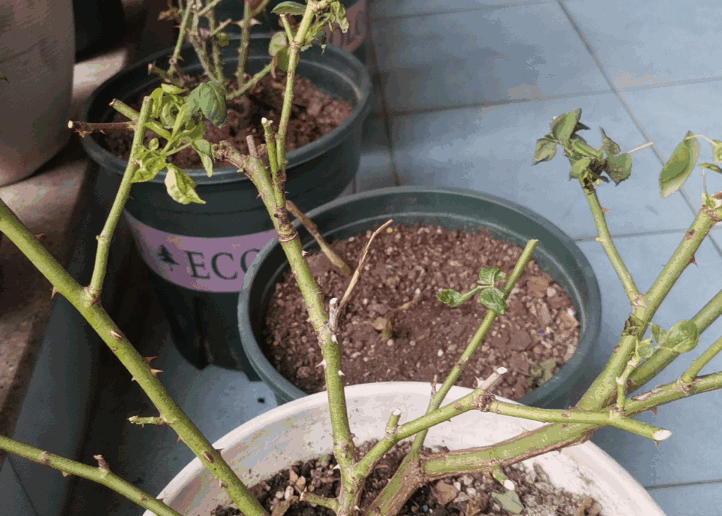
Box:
263;225;579;399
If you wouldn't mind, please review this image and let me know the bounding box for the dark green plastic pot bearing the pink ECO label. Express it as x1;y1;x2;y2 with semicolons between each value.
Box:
81;36;371;379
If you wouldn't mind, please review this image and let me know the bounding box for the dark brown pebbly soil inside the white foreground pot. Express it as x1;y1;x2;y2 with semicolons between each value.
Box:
211;441;602;516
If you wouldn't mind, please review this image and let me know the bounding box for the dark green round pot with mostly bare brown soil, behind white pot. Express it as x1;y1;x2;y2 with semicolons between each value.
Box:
238;187;602;408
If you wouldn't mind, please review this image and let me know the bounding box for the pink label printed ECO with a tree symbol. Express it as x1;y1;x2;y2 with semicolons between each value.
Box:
125;211;276;292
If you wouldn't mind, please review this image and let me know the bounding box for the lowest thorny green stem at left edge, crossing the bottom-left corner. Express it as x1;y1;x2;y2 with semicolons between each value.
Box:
0;435;182;516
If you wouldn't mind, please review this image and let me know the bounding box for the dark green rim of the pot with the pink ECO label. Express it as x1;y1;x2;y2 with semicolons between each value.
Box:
80;34;372;186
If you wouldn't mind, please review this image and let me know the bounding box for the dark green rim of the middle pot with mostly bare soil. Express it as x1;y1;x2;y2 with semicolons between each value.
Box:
238;186;602;406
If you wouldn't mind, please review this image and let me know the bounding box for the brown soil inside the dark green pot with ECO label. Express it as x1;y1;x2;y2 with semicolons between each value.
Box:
100;72;353;170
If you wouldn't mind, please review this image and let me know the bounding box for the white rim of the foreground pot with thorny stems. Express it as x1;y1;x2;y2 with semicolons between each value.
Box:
144;382;664;516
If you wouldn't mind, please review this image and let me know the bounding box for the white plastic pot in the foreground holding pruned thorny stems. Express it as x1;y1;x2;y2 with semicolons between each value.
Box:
144;382;664;516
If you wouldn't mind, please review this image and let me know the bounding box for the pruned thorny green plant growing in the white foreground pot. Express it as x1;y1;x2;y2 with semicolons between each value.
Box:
0;0;722;508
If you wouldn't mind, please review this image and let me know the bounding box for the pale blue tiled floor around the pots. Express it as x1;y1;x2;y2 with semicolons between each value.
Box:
67;0;722;516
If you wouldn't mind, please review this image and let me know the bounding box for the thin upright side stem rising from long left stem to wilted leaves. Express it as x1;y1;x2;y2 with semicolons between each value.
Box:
87;97;153;303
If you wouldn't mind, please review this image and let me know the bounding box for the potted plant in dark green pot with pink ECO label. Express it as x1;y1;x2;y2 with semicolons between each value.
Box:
76;2;371;372
